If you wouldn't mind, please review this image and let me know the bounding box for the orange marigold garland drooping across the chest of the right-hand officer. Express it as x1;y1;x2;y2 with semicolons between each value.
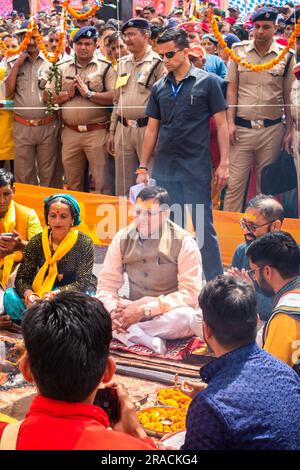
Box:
207;8;300;72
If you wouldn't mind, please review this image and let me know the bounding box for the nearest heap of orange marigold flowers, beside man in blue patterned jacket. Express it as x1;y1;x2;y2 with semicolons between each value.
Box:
138;406;186;437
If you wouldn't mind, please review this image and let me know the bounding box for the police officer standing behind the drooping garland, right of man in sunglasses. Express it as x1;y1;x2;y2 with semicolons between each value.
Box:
224;8;295;212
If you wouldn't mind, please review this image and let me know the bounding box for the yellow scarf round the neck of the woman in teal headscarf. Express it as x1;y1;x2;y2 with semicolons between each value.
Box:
32;227;78;297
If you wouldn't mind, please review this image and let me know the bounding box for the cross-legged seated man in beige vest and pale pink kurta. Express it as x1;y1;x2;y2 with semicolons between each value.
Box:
97;187;202;354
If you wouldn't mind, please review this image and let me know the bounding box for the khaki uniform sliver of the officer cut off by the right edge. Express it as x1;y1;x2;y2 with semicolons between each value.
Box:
291;80;300;217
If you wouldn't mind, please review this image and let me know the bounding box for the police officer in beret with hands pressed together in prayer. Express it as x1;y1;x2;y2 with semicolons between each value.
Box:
47;26;115;194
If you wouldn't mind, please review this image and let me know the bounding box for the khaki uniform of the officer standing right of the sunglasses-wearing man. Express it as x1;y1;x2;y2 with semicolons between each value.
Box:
224;41;295;212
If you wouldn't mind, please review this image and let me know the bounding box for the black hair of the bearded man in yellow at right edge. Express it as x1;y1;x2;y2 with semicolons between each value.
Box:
246;231;300;279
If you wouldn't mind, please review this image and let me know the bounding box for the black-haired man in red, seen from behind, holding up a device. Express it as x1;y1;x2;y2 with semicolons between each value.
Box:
0;292;155;451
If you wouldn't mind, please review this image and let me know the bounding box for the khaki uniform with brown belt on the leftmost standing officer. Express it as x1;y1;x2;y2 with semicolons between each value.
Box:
8;53;59;186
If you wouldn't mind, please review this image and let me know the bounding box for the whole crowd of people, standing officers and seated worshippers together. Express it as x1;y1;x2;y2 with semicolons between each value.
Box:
0;1;300;450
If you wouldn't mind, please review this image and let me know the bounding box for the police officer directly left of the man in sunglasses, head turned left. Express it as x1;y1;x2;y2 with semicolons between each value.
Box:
109;18;165;195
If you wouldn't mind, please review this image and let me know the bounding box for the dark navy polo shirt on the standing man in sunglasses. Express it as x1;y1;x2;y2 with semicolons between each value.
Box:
146;66;227;181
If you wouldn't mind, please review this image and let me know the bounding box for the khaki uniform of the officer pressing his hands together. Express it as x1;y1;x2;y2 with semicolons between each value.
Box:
55;55;115;194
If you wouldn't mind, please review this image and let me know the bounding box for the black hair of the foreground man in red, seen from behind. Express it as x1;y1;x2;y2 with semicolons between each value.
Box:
22;292;112;403
